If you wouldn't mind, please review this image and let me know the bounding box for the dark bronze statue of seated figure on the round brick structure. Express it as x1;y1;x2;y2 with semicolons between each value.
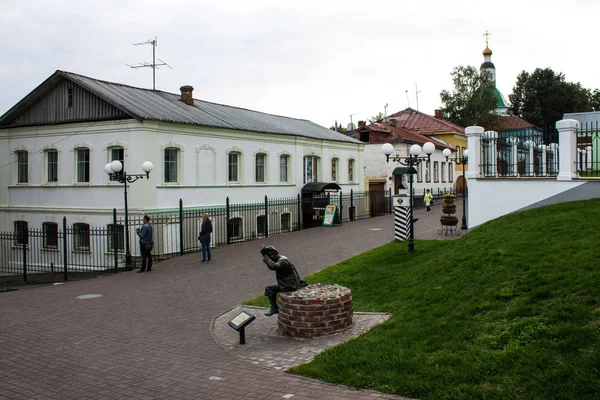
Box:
260;246;308;317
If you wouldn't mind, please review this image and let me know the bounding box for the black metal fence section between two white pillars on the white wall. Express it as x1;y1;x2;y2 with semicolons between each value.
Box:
479;127;559;177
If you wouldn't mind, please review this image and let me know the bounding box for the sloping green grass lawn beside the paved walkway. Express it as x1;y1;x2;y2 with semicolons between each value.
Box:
247;200;600;399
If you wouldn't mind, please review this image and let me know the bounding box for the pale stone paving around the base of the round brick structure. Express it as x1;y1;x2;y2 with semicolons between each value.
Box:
213;306;390;371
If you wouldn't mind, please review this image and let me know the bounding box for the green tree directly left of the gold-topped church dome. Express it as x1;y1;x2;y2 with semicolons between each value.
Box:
440;65;497;129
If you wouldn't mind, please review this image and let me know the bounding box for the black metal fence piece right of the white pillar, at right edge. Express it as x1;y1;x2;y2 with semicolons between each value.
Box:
576;122;600;178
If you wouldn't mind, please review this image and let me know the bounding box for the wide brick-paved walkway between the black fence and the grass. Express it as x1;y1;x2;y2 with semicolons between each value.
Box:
0;204;462;400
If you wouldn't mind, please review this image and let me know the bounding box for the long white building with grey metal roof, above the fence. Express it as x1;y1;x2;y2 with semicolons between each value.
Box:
0;71;364;231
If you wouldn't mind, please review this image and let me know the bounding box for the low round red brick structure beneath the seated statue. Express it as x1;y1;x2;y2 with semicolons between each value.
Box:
277;284;354;338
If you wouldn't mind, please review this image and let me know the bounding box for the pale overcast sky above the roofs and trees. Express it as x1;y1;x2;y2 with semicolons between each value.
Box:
0;0;600;127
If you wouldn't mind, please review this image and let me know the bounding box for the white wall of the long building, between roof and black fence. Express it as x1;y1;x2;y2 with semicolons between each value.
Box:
0;121;364;231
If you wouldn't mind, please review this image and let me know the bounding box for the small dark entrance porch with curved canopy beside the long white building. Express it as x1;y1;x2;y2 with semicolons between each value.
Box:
302;182;342;229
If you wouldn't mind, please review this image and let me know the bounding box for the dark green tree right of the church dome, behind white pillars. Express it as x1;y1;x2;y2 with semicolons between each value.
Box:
508;68;600;127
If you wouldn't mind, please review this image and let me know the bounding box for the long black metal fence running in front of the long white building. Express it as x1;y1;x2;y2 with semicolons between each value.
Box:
0;191;398;282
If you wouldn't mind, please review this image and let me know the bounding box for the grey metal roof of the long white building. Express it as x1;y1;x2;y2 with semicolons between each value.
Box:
0;70;362;144
